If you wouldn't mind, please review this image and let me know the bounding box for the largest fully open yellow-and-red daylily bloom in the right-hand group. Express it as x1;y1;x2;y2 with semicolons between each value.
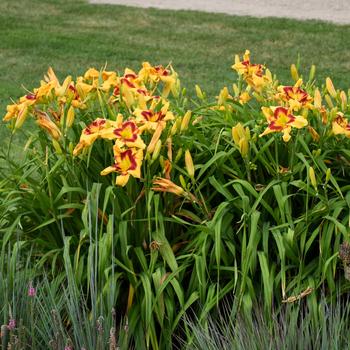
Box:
259;107;308;142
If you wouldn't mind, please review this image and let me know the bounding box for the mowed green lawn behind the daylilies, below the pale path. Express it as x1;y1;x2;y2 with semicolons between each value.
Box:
0;0;350;142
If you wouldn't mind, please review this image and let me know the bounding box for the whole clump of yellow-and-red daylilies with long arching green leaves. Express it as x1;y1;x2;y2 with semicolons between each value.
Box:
0;51;350;349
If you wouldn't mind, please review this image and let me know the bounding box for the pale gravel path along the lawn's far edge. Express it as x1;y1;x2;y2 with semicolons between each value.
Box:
90;0;350;24
